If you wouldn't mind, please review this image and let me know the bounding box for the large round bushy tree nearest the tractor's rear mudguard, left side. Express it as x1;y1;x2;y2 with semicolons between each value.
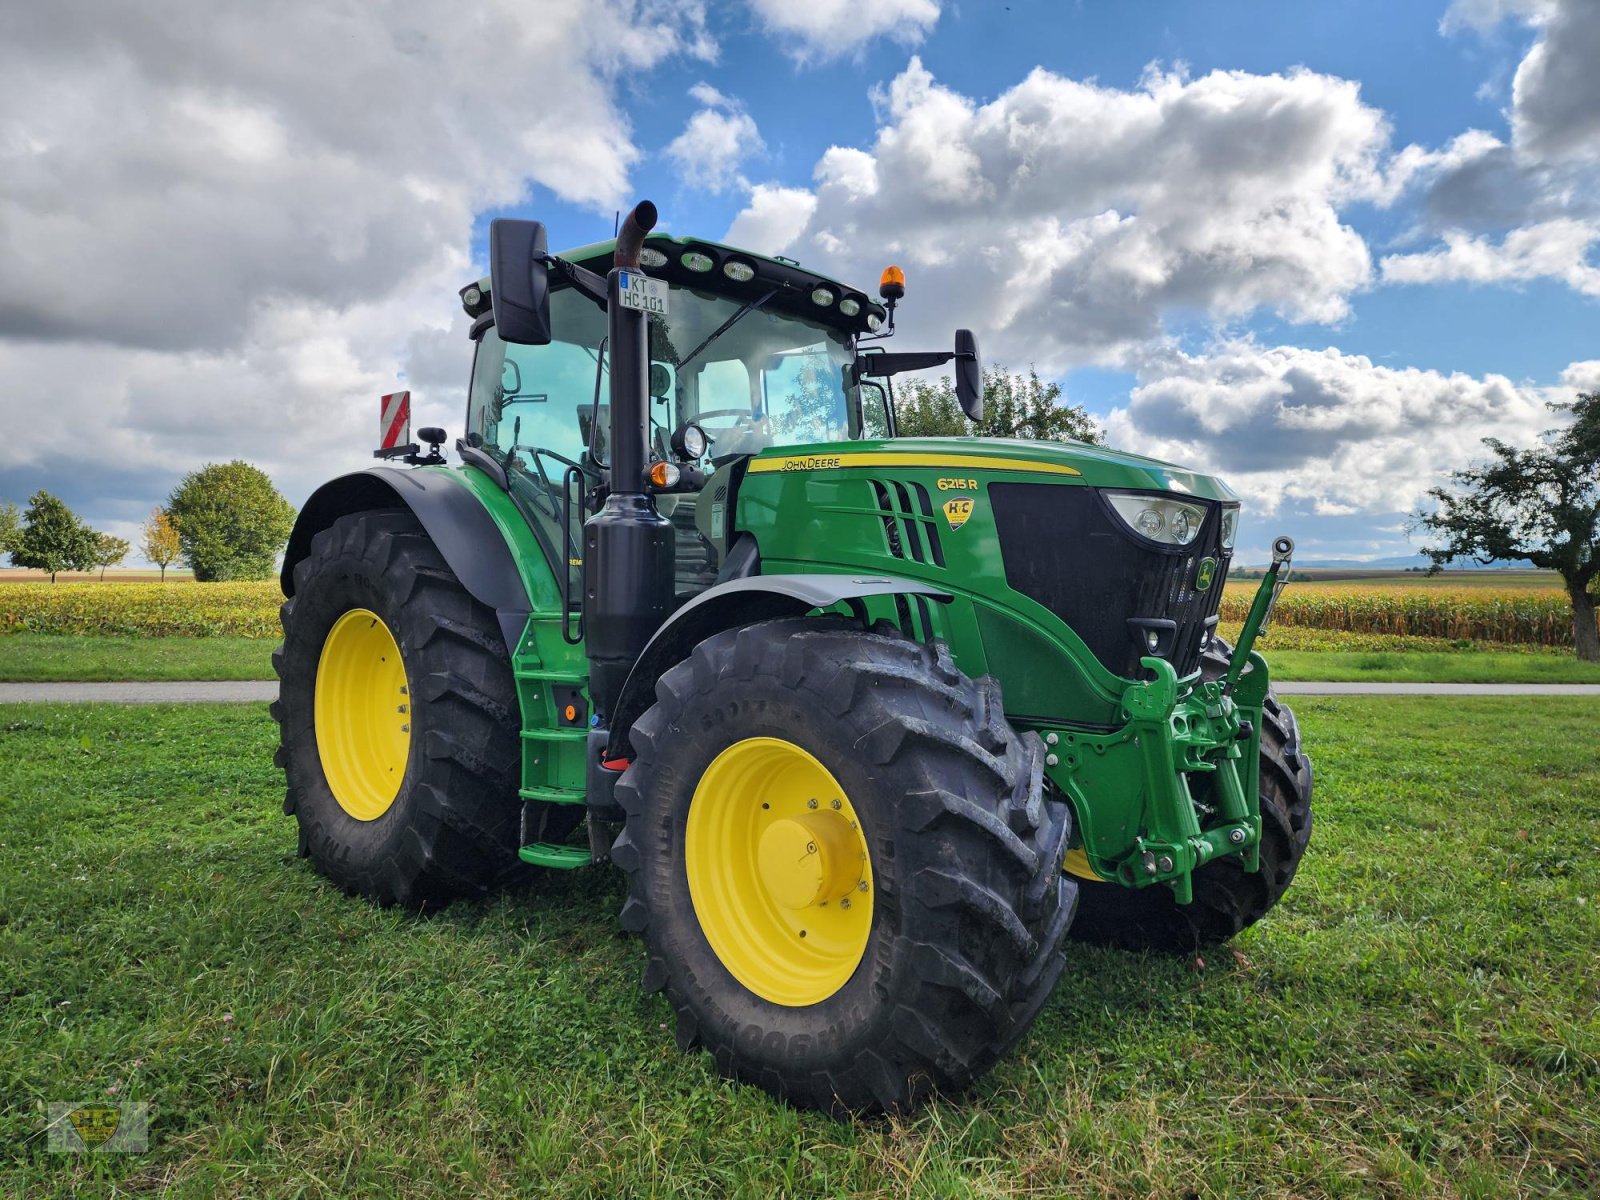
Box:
166;459;294;582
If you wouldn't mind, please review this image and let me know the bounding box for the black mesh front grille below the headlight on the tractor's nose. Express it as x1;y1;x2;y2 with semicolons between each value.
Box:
989;483;1232;678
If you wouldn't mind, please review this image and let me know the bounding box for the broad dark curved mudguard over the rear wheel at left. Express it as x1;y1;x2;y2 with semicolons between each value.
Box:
280;467;531;654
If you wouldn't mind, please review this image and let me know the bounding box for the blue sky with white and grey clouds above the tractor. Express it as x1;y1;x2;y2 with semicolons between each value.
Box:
0;0;1600;563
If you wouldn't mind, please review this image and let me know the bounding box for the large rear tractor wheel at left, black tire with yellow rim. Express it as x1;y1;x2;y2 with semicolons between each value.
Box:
272;510;550;907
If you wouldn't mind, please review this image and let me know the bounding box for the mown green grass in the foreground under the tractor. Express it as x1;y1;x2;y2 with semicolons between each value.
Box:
0;698;1600;1197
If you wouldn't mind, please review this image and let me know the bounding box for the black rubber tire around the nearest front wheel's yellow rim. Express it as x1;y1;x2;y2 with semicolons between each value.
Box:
613;619;1077;1112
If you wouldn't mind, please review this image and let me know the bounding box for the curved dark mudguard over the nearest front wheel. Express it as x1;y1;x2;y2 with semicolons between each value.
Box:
610;574;952;757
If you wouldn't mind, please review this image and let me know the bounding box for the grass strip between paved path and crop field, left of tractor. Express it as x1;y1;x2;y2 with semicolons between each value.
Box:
0;634;277;683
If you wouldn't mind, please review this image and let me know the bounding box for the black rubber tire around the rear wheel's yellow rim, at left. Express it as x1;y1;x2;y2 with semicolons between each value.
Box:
272;510;553;909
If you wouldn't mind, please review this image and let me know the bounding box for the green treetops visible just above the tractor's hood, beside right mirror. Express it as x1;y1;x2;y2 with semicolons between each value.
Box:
894;366;1101;442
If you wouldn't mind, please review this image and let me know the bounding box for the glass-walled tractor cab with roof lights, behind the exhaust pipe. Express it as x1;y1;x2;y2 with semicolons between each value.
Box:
464;237;893;603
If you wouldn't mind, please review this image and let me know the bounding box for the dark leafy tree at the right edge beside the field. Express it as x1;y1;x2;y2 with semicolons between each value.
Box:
1414;392;1600;662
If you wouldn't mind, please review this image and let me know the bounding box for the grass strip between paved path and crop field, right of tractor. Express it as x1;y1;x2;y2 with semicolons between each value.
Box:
1261;645;1600;683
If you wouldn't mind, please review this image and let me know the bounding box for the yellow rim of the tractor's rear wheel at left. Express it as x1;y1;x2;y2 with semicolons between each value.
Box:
314;608;411;821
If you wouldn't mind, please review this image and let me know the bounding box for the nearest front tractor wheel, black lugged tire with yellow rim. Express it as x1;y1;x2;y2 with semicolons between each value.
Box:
613;619;1077;1110
